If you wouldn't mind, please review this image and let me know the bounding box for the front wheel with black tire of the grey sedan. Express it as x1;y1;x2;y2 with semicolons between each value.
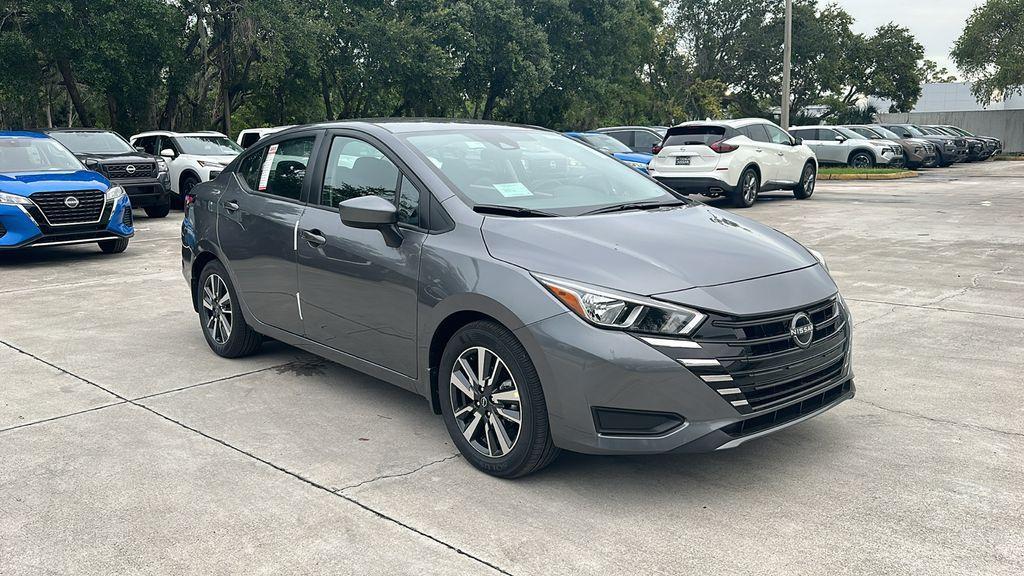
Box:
438;321;560;478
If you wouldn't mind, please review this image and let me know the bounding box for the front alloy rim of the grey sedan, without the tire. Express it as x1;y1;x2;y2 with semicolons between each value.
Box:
450;346;522;458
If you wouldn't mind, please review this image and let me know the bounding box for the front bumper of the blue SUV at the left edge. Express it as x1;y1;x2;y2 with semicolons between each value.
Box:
0;196;135;250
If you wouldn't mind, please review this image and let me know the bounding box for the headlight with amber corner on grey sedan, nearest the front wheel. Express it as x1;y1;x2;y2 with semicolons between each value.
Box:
535;275;705;336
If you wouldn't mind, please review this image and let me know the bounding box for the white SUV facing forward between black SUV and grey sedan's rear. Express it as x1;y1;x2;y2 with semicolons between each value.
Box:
129;131;242;202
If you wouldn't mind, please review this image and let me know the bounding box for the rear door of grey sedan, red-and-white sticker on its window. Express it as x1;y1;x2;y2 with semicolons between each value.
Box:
217;133;316;334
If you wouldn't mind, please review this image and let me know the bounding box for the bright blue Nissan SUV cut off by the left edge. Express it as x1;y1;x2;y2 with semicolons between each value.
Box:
0;131;135;254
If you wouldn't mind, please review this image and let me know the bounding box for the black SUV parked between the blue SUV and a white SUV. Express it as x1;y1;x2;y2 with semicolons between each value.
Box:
40;128;171;218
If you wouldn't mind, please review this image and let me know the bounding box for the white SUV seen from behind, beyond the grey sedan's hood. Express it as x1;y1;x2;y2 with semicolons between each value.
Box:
647;118;818;208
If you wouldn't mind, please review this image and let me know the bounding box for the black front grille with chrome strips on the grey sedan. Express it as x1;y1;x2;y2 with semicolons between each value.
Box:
663;297;850;413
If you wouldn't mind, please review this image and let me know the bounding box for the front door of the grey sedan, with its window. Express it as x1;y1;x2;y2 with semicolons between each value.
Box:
298;132;426;377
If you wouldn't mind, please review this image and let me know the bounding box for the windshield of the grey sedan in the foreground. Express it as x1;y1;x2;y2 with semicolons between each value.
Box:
402;128;680;216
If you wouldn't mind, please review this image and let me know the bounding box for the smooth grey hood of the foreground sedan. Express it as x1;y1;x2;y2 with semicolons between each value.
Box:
482;204;817;295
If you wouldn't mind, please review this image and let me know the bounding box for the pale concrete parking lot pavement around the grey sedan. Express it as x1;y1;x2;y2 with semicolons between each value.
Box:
0;157;1024;575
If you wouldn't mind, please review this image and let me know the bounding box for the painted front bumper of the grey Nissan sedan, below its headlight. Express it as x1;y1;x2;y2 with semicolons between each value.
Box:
519;297;855;454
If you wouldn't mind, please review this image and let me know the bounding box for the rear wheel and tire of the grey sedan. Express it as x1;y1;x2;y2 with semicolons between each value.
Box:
197;260;263;358
